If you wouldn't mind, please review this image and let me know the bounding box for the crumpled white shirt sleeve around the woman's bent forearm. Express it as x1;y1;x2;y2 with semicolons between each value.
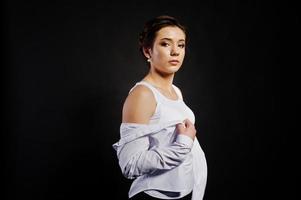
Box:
118;134;193;179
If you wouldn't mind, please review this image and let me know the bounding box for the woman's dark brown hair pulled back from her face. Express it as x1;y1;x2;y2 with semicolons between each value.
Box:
139;15;187;55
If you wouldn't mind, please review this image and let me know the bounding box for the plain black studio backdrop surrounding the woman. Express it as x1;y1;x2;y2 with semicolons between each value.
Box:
1;0;300;200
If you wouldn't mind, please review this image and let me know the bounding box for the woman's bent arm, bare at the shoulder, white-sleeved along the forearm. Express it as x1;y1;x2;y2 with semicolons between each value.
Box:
118;86;194;178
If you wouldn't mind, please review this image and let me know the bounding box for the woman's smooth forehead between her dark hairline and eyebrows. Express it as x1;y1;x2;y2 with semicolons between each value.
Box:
156;26;185;40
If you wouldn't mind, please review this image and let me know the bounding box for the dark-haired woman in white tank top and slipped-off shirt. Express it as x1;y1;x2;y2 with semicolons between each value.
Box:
113;16;207;200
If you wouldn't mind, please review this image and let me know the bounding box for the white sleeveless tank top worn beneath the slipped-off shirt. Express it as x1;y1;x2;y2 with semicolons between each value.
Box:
130;80;195;199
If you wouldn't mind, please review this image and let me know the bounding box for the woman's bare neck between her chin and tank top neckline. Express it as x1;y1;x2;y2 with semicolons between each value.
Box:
143;67;174;92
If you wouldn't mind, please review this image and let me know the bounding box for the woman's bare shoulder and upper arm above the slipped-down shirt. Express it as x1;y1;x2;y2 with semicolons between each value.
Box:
122;85;156;124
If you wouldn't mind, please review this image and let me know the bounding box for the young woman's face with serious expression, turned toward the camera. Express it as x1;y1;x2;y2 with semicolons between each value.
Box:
149;26;186;74
